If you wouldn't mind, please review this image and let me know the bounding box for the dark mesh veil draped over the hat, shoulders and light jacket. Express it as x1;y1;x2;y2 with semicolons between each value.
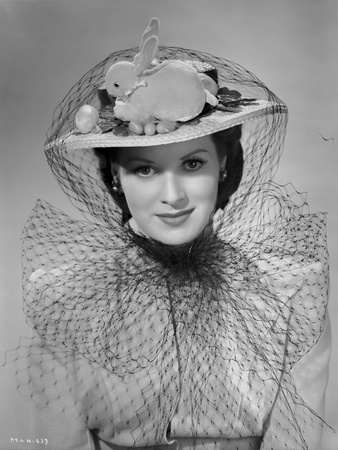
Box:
4;47;328;449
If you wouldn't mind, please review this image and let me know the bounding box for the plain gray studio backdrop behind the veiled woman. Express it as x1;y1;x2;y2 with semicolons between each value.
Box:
0;0;338;450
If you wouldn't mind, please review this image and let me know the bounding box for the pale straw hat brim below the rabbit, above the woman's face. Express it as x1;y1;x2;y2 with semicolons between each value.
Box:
45;100;287;150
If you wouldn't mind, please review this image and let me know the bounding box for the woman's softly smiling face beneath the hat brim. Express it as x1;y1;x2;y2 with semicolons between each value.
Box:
113;136;225;245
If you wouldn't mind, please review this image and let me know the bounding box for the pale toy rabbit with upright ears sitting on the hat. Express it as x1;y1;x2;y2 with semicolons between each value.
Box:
105;18;218;134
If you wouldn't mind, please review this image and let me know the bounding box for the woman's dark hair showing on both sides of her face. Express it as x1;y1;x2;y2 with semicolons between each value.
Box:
94;125;243;222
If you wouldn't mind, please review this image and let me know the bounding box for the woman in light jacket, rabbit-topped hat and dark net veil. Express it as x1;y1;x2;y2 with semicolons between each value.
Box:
7;17;330;450
